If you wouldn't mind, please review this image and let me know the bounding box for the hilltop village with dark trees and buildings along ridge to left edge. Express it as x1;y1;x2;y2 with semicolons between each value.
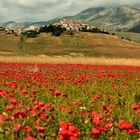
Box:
0;19;108;36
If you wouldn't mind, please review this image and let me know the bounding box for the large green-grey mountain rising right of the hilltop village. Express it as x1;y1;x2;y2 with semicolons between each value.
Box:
73;6;140;31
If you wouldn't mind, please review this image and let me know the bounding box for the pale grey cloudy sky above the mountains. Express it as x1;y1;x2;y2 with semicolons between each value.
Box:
0;0;140;22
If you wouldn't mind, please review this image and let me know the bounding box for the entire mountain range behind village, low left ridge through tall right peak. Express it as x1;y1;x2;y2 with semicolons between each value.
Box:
3;5;140;32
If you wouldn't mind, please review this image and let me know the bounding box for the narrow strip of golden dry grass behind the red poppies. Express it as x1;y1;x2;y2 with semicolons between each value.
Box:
0;55;140;66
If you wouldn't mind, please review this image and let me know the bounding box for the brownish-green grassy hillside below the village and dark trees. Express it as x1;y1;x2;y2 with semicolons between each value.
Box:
0;33;140;58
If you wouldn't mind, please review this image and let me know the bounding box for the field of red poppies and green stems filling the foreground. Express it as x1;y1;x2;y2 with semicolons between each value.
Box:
0;62;140;140
